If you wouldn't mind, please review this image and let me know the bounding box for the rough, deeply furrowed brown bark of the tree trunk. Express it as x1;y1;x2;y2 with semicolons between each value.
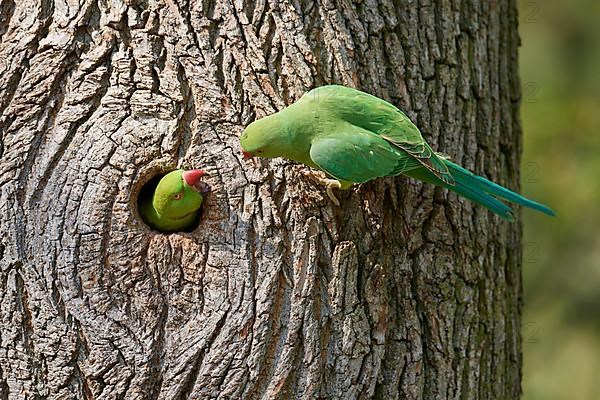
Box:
0;0;521;399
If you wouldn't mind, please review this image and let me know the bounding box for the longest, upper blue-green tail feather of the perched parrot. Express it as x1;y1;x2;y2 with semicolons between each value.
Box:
444;160;555;216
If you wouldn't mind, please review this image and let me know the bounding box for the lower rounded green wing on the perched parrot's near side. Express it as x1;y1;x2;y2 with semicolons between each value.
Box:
310;124;421;183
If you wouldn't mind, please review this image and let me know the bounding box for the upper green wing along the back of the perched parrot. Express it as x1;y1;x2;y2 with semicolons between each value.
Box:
307;85;454;185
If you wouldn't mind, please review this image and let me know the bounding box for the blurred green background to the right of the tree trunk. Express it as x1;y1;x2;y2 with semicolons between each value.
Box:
519;0;600;400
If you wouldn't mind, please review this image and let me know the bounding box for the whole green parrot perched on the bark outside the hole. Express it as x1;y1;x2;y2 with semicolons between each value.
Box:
240;85;554;221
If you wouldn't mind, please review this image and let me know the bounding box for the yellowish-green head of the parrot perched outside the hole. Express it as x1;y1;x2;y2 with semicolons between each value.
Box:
240;114;290;159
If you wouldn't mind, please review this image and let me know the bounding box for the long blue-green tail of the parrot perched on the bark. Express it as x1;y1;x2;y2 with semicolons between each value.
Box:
407;160;554;221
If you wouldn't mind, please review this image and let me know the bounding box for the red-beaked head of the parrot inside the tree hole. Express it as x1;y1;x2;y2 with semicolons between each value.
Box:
152;169;210;219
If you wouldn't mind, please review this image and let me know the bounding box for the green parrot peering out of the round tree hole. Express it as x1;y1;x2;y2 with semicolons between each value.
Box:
139;169;210;232
